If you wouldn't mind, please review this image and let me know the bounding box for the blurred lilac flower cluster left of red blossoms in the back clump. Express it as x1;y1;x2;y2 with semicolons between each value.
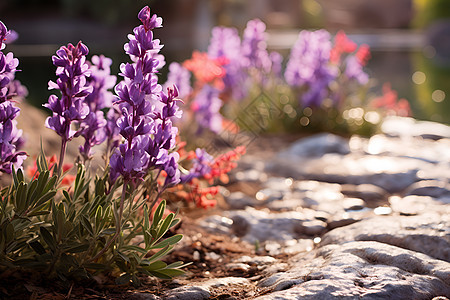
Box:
284;30;337;106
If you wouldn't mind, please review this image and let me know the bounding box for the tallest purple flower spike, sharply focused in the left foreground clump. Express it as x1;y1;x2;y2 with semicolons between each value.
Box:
110;6;181;186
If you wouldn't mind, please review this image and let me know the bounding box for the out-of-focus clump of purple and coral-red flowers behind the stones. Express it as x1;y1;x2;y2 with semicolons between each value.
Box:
168;20;410;135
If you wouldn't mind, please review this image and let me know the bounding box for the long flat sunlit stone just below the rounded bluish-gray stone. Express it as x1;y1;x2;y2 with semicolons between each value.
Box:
267;153;424;193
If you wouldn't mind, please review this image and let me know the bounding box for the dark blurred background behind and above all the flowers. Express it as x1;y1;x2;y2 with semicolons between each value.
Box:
0;0;450;123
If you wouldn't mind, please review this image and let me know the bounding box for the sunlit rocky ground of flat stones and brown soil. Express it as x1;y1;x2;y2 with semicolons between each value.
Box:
7;102;450;300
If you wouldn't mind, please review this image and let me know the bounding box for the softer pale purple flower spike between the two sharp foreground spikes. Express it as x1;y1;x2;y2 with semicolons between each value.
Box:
79;55;118;160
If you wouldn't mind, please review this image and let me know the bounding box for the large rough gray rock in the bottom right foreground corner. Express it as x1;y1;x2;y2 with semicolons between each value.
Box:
256;242;450;300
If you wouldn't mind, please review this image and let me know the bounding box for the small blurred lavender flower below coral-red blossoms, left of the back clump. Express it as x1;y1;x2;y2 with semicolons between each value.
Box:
192;85;222;133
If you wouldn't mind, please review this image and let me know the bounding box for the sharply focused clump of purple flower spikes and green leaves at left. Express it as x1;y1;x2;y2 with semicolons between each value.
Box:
0;7;243;285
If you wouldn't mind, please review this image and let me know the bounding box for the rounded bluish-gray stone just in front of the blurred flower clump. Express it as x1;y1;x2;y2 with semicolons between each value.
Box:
279;133;350;157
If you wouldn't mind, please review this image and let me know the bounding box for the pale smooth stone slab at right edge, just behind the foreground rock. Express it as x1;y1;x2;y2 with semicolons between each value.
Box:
320;212;450;261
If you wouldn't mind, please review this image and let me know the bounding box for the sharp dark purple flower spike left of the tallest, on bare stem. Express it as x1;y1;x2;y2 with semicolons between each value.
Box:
44;42;93;143
